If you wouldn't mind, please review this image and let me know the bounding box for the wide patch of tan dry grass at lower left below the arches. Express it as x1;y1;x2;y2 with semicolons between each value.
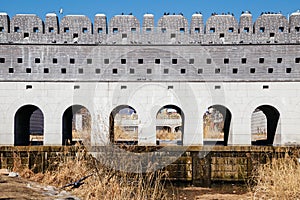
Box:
14;148;172;200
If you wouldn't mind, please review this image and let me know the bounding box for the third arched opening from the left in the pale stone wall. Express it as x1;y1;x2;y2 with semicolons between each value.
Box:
109;105;139;145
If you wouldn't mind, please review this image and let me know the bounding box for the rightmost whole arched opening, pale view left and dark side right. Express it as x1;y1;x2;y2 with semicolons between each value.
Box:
251;105;280;145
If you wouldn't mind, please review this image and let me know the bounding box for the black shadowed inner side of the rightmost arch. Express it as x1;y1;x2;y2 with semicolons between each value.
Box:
252;105;280;145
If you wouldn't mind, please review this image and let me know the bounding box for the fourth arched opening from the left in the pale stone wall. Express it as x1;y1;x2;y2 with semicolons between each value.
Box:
156;105;184;145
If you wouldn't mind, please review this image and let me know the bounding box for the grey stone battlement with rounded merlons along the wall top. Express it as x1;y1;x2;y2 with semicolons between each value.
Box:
0;11;300;44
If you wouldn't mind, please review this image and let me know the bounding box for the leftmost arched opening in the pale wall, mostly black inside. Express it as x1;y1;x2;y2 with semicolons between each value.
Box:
14;105;44;146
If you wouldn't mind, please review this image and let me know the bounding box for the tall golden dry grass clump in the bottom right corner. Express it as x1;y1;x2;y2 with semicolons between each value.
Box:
252;157;300;199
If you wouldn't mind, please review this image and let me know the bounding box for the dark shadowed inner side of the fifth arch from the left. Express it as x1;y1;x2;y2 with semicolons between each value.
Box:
203;105;232;146
